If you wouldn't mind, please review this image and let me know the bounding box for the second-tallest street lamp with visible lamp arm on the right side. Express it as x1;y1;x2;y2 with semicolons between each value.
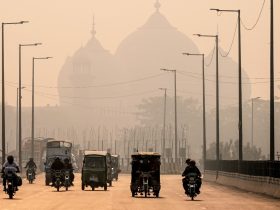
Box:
194;34;220;161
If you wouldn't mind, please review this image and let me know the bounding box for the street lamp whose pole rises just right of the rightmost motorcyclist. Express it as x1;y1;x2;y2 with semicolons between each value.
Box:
182;53;206;168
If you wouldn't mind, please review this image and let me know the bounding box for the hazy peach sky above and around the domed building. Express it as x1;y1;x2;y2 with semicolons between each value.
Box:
0;0;280;106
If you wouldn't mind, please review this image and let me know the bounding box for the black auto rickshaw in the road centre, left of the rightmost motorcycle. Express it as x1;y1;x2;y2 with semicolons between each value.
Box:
130;152;161;197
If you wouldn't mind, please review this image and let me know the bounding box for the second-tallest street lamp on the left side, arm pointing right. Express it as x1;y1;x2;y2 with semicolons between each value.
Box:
18;43;42;169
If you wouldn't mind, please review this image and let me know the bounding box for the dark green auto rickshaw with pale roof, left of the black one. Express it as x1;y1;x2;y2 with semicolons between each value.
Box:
81;151;112;191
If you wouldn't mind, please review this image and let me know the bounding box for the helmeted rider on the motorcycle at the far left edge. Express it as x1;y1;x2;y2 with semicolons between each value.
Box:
1;155;19;191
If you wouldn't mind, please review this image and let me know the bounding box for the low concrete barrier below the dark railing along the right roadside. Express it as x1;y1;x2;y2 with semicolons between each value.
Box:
203;170;280;198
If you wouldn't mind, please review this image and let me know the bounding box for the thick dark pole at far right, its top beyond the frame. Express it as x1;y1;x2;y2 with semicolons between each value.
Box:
270;0;274;161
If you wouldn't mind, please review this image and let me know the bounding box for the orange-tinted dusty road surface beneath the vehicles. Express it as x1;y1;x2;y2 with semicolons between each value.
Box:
0;174;280;210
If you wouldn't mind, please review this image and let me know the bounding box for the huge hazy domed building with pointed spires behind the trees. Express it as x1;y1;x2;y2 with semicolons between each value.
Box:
58;1;251;115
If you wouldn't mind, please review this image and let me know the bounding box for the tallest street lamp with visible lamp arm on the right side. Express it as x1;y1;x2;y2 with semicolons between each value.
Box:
210;9;243;160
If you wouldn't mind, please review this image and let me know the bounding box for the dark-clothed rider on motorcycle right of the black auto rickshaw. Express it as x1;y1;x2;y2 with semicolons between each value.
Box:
182;159;201;194
